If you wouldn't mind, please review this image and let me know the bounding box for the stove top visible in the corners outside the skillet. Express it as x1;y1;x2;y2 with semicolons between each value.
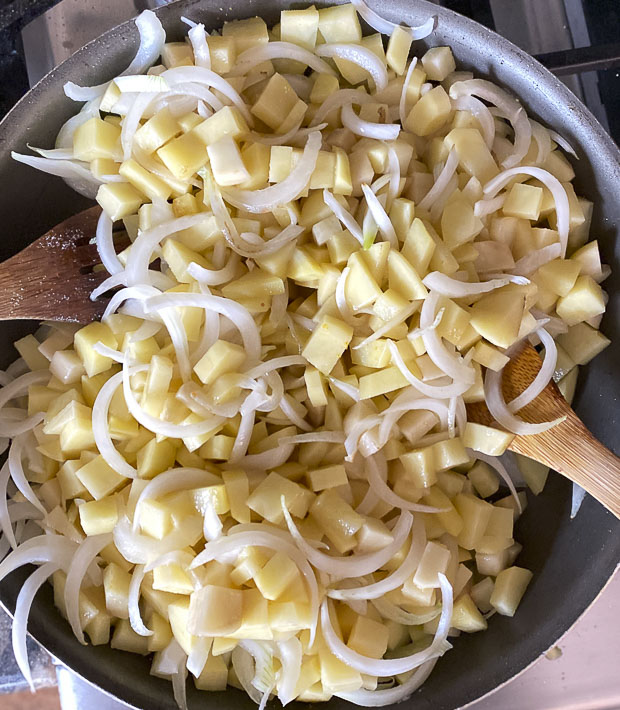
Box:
0;0;620;710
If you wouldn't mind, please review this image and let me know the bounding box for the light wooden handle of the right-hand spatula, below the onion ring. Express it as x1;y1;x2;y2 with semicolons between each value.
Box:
510;411;620;518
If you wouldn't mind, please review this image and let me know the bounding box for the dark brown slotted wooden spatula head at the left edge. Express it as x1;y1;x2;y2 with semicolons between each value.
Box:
0;207;120;323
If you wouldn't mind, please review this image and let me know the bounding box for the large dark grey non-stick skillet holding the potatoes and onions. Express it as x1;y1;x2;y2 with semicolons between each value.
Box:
0;0;620;710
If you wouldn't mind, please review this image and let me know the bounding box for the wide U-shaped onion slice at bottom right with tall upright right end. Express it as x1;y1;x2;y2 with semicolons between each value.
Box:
321;573;453;677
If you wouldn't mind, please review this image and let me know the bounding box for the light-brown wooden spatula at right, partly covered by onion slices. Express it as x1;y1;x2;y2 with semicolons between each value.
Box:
467;345;620;518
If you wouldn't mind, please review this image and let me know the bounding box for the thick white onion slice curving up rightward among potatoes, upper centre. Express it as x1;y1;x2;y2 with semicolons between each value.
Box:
222;131;322;213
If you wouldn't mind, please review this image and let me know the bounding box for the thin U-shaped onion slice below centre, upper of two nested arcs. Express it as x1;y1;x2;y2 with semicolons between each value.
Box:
282;504;413;579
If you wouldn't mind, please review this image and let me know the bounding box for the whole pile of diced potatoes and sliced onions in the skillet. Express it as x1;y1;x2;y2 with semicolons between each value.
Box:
0;0;609;707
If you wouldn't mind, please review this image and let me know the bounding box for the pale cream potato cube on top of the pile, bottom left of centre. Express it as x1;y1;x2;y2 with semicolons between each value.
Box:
187;584;243;636
